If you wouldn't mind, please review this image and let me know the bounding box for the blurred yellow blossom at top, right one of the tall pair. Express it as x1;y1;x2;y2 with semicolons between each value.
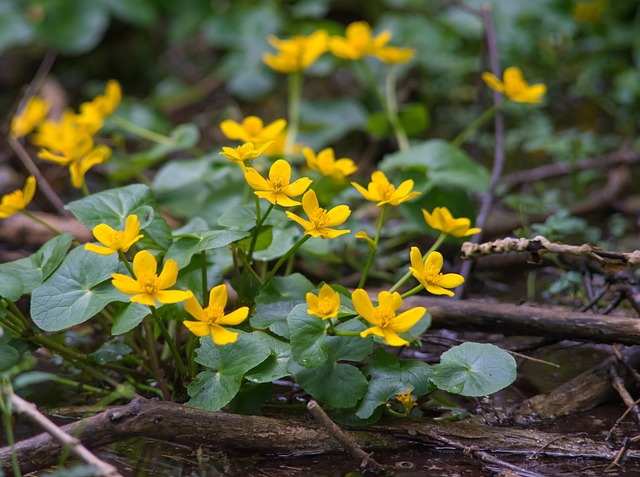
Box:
329;22;414;63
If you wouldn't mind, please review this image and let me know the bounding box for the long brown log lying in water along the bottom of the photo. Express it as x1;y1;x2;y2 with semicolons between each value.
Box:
0;399;640;472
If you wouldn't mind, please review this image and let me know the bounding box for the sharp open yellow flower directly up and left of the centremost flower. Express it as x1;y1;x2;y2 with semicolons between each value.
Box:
244;159;313;207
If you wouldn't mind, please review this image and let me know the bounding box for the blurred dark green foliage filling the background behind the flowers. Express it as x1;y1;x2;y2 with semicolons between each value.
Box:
0;0;640;245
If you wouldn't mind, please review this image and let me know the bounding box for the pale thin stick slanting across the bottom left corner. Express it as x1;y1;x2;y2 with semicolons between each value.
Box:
11;394;122;477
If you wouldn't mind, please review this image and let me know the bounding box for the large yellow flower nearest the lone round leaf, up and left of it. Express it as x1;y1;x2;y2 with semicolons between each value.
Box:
351;288;427;346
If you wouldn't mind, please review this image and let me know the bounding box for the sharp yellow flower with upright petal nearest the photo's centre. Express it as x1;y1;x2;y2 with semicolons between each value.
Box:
286;189;351;239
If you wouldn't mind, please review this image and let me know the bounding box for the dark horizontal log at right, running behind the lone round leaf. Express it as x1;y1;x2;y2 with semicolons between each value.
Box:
404;295;640;345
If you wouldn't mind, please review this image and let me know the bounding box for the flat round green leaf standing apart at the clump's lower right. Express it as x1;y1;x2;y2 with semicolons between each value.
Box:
431;343;517;396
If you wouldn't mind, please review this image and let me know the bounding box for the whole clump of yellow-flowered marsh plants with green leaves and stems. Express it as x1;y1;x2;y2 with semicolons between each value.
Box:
0;15;560;423
